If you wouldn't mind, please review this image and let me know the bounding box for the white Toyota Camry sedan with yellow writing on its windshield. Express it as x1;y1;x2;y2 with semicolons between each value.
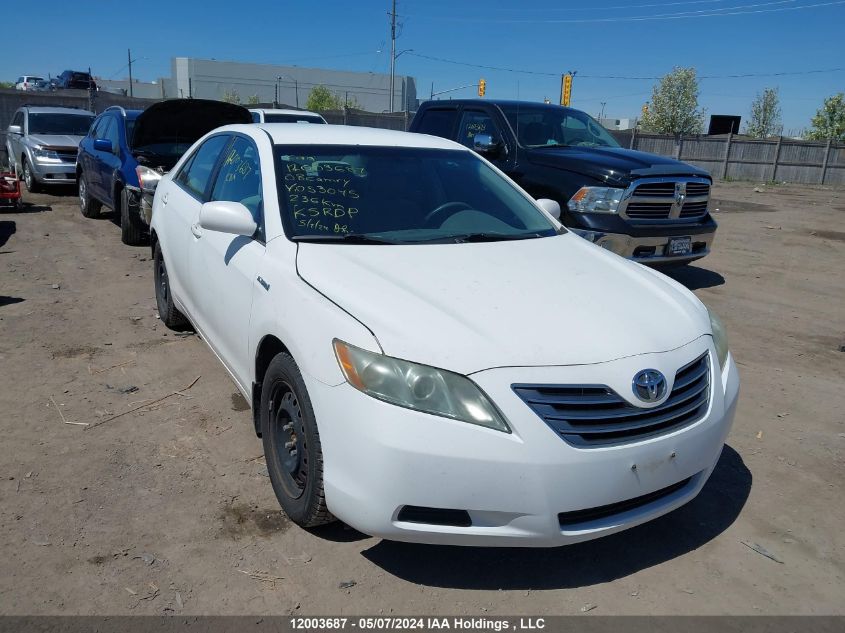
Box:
151;124;739;546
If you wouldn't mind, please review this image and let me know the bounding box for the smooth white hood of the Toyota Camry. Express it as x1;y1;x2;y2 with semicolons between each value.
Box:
297;233;710;374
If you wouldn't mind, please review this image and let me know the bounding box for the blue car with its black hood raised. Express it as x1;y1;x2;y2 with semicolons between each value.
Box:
76;99;252;245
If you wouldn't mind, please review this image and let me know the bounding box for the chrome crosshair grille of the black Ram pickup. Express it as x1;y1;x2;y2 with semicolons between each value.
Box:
619;178;710;223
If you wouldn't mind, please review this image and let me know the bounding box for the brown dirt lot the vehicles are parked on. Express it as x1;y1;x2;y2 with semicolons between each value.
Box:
0;183;845;615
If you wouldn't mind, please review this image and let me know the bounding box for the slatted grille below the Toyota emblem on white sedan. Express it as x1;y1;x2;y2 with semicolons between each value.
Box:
512;353;710;448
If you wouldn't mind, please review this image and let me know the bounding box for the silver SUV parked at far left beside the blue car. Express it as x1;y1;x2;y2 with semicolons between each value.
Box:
6;106;94;192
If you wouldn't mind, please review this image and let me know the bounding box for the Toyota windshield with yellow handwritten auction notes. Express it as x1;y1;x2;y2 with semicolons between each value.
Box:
275;145;563;243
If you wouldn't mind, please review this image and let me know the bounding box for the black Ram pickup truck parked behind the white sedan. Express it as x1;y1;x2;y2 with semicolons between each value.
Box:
409;99;716;264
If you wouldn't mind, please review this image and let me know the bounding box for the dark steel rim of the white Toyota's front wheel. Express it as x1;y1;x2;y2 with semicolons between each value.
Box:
269;381;308;499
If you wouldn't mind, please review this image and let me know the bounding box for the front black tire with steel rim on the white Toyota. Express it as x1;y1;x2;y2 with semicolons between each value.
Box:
259;353;335;527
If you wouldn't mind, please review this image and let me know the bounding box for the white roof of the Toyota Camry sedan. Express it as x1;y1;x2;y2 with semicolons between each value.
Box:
224;123;469;152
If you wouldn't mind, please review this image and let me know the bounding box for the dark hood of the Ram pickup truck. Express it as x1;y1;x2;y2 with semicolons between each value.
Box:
526;147;710;184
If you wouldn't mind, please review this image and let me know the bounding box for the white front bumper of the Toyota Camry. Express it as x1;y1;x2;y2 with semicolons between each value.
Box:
305;336;739;547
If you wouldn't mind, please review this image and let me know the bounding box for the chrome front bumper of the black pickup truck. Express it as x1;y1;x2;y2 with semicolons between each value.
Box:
570;228;716;264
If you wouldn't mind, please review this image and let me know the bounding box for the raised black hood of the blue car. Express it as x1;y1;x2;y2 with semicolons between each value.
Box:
131;99;252;147
